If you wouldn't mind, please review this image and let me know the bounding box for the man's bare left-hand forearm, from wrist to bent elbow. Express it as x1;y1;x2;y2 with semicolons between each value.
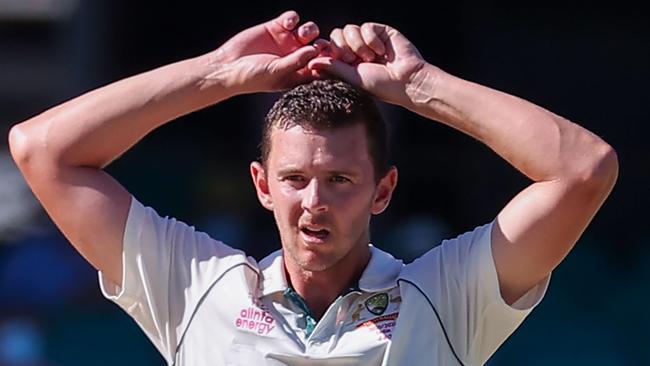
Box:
10;50;230;168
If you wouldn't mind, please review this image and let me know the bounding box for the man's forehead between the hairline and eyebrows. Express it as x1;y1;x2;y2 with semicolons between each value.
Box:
268;124;372;171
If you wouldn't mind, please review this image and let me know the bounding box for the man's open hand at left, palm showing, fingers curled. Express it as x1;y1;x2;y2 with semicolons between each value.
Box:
211;10;320;93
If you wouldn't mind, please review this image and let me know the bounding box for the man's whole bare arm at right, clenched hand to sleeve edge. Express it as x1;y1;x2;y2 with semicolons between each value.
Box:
310;23;618;303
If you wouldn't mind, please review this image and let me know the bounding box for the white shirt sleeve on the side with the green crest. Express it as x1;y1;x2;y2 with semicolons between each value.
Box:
402;224;550;365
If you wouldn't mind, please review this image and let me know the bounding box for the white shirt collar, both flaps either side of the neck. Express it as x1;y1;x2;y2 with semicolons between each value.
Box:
259;245;404;296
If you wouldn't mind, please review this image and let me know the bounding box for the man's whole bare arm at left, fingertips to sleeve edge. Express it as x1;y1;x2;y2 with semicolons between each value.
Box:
9;11;318;284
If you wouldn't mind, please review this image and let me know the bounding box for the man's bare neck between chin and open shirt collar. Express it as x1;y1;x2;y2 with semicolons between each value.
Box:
285;245;370;319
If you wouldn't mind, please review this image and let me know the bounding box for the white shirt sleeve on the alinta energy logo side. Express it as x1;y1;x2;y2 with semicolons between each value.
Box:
99;197;246;363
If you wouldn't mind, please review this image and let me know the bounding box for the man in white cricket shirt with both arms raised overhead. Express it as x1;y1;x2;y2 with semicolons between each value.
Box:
9;11;618;365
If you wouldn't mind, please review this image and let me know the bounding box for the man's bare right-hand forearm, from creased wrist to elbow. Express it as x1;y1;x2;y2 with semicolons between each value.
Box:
407;65;615;181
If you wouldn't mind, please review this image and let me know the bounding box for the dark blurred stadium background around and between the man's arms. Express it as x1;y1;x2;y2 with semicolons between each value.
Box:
0;0;650;366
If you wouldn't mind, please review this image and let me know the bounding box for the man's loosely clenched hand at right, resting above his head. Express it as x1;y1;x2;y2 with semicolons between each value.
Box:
309;23;426;106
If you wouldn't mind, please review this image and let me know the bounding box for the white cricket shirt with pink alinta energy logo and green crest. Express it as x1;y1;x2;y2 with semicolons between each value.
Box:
99;198;548;366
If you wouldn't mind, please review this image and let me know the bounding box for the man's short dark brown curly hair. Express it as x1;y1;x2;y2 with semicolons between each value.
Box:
260;79;389;182
